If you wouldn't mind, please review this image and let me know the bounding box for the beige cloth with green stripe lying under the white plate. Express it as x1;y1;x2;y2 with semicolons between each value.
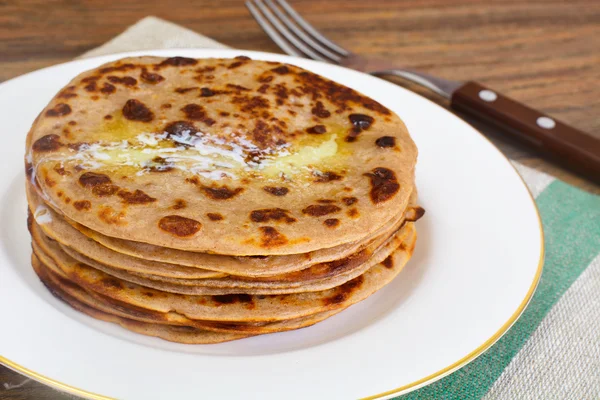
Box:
84;17;600;400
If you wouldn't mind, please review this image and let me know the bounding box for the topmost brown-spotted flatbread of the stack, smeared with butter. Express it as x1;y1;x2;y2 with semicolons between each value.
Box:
26;57;417;255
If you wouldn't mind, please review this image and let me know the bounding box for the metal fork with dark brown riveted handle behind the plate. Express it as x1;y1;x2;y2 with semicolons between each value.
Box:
246;0;600;183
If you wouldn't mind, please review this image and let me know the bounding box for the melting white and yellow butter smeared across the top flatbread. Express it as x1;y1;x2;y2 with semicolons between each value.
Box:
62;125;350;180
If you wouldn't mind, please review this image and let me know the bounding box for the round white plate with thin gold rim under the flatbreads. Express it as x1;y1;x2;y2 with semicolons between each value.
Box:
0;49;543;400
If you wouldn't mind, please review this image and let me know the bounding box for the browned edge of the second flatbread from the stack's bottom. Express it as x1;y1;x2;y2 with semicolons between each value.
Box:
36;222;416;322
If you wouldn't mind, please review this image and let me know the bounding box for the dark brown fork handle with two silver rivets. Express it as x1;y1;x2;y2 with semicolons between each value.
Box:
451;82;600;183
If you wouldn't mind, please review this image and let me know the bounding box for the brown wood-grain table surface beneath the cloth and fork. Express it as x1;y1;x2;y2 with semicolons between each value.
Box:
0;0;600;399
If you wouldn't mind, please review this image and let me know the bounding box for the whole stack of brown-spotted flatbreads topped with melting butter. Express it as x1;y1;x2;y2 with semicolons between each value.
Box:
26;56;423;343
